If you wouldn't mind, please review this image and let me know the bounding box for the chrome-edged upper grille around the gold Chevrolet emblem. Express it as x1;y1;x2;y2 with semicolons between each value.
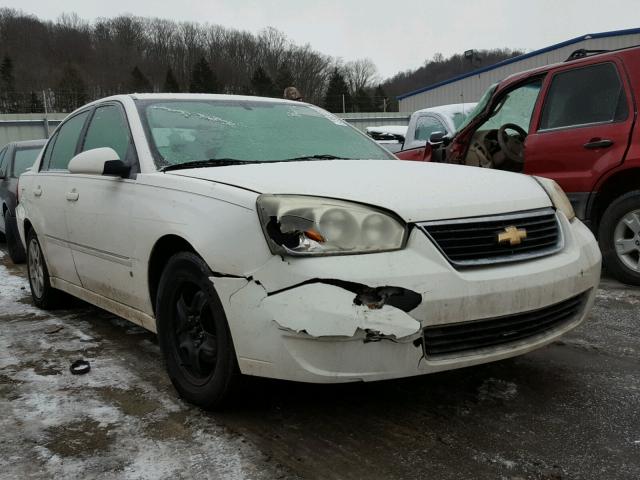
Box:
418;208;563;267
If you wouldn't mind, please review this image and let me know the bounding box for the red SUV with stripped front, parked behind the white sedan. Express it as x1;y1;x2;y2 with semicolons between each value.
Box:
396;47;640;285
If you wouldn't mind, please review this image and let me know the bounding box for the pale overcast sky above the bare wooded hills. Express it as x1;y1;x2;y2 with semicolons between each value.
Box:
2;0;640;78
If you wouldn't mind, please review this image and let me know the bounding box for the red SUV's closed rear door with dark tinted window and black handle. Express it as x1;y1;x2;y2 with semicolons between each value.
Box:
525;59;633;216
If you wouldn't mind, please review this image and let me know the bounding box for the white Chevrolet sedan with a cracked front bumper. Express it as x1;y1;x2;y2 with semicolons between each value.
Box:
18;94;600;407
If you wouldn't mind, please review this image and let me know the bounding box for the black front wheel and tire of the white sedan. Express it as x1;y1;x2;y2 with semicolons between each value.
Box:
156;252;238;409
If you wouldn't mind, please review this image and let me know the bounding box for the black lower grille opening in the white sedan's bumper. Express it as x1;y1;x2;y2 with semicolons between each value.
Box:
422;292;588;357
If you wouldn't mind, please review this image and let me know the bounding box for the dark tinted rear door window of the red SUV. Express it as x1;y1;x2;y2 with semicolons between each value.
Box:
540;63;629;130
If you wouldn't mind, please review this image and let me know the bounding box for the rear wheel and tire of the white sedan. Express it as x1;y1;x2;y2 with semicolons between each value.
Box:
27;229;63;310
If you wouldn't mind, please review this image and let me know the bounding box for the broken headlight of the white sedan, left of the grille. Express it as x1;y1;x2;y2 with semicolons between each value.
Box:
257;195;406;255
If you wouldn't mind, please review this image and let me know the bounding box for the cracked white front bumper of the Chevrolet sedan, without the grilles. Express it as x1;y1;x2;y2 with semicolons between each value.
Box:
211;217;600;383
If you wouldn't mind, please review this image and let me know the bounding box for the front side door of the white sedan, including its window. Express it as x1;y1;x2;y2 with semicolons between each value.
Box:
66;103;139;307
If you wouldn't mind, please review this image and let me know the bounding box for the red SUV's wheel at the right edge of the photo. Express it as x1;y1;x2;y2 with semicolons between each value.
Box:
598;190;640;285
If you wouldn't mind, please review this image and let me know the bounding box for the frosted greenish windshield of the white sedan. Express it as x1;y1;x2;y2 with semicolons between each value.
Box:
138;100;394;167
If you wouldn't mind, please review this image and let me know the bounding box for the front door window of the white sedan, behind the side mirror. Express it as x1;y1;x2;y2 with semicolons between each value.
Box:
82;105;131;163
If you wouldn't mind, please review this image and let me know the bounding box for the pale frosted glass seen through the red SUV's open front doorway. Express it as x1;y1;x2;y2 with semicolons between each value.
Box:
479;79;542;132
